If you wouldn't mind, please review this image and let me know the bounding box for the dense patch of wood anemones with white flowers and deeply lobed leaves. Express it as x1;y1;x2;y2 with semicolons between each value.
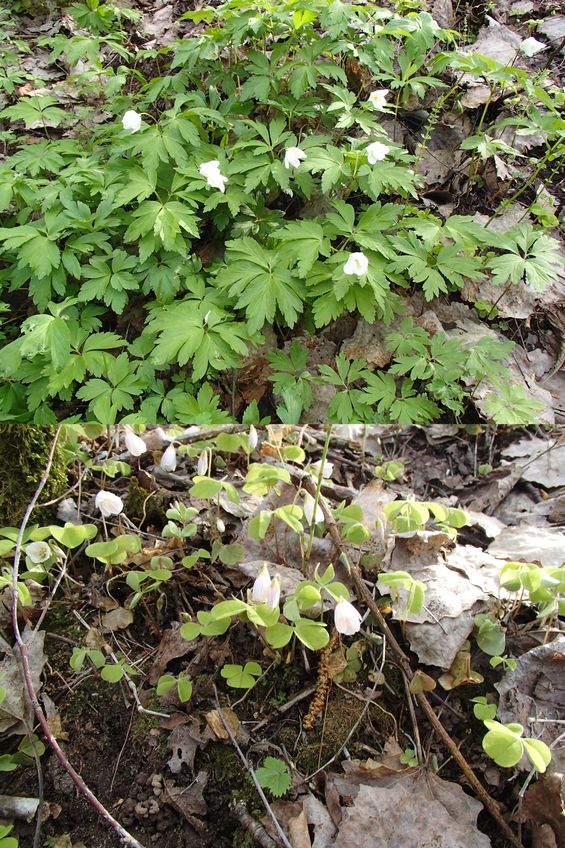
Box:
0;0;564;423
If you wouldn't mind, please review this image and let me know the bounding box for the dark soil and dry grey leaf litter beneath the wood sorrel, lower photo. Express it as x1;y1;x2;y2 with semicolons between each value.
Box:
0;426;565;848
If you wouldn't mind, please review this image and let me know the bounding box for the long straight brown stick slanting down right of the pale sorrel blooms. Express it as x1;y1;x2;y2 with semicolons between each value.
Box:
301;474;524;848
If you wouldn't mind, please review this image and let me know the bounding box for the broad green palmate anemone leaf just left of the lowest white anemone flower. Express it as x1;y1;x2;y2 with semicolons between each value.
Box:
217;238;305;332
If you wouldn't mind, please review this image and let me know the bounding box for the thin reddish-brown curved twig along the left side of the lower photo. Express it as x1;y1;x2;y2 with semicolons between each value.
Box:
12;425;148;848
